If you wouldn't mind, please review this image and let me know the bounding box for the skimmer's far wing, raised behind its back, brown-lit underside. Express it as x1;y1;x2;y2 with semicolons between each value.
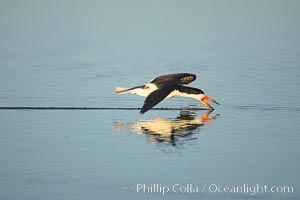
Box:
150;73;197;87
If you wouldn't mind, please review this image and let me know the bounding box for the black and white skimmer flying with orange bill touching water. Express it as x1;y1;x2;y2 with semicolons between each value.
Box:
115;73;220;114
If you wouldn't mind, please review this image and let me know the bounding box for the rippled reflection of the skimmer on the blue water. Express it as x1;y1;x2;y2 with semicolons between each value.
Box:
114;110;219;146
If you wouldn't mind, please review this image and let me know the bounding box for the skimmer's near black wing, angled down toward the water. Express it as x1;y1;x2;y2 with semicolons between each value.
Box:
140;81;179;114
